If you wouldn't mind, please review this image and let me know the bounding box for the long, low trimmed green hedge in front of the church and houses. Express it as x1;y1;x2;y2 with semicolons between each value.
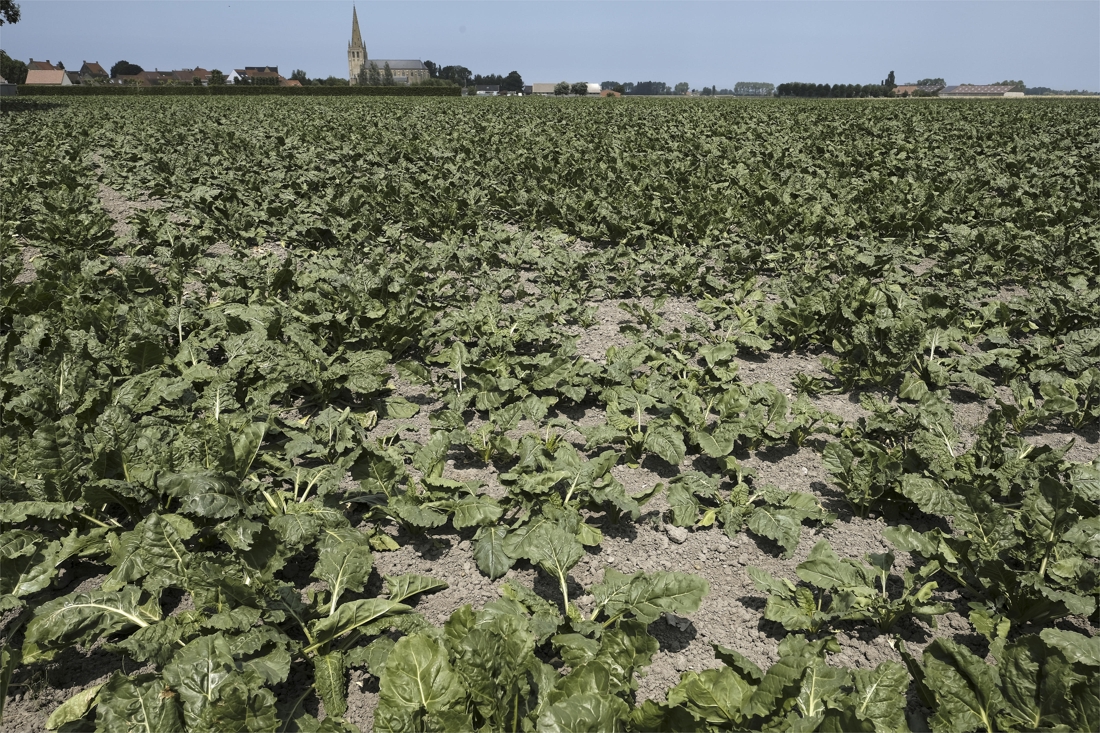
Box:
19;84;462;97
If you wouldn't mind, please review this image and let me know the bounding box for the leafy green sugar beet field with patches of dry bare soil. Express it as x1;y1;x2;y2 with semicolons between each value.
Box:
0;97;1100;733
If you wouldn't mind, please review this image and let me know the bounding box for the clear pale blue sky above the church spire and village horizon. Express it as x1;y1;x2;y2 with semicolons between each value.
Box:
0;0;1100;91
